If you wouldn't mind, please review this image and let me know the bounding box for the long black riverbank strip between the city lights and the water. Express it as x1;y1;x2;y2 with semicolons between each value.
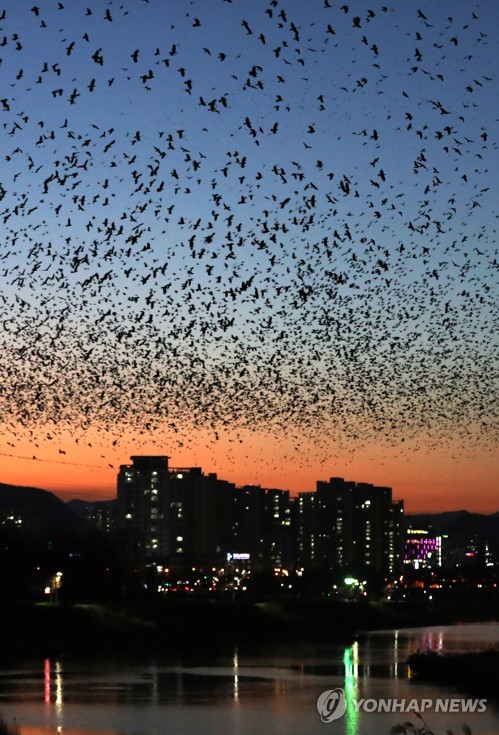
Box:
0;597;464;656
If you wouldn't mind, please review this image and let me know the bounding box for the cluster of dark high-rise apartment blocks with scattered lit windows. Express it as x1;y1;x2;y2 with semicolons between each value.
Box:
114;455;404;576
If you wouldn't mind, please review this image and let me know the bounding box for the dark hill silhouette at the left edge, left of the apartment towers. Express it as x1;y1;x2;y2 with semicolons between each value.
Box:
0;483;84;535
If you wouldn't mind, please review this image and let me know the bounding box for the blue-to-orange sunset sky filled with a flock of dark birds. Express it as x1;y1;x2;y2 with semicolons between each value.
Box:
0;0;499;513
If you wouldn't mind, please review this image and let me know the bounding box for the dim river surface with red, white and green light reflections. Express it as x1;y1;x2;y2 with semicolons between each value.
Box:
0;624;499;735
